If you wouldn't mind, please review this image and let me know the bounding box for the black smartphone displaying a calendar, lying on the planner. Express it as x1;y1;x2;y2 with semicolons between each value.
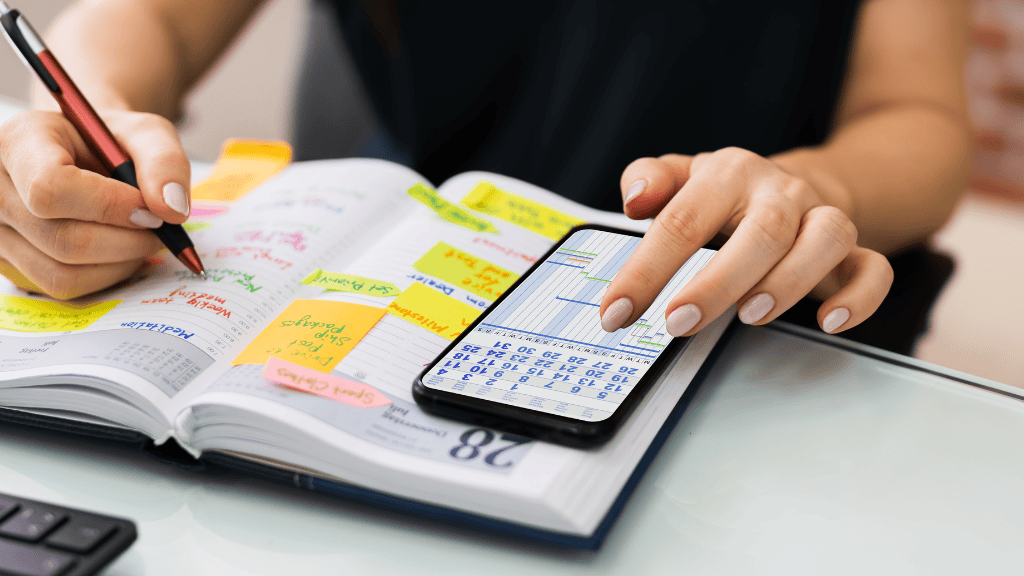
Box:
413;224;716;447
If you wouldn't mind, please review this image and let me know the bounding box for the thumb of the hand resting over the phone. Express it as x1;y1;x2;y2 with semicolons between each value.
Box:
620;154;693;220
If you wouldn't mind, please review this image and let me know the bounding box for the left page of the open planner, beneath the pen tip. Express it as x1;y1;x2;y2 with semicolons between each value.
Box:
0;160;421;417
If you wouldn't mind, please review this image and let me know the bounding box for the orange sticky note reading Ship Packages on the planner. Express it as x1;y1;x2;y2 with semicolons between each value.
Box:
231;299;384;372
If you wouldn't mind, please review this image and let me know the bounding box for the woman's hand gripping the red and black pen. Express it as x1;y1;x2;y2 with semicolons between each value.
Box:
0;111;191;299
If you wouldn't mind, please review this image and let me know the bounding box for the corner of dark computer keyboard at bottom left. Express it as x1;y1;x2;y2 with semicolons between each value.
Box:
0;493;137;576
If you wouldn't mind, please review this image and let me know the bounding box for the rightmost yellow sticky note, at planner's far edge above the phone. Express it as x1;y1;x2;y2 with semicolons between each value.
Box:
462;182;585;240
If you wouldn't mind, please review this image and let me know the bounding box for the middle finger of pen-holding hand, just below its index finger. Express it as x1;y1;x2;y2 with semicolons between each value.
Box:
0;168;162;264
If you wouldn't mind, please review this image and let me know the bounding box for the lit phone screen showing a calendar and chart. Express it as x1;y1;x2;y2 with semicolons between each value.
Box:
422;230;715;422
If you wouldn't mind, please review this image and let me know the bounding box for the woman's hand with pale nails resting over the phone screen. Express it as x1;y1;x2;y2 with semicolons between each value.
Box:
601;149;893;336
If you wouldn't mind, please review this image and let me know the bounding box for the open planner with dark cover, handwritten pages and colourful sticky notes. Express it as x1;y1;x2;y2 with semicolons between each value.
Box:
0;159;731;547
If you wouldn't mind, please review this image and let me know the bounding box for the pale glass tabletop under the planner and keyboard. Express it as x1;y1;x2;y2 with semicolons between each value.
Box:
0;97;1024;576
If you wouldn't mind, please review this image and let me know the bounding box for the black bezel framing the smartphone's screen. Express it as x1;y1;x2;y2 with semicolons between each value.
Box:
413;224;691;447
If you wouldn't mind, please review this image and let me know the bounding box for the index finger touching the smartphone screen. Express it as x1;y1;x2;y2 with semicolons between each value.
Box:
600;152;745;332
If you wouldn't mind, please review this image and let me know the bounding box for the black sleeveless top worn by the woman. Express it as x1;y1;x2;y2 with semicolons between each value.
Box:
327;0;857;210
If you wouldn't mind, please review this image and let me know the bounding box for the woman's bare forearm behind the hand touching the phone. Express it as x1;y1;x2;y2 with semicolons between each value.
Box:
772;104;971;253
